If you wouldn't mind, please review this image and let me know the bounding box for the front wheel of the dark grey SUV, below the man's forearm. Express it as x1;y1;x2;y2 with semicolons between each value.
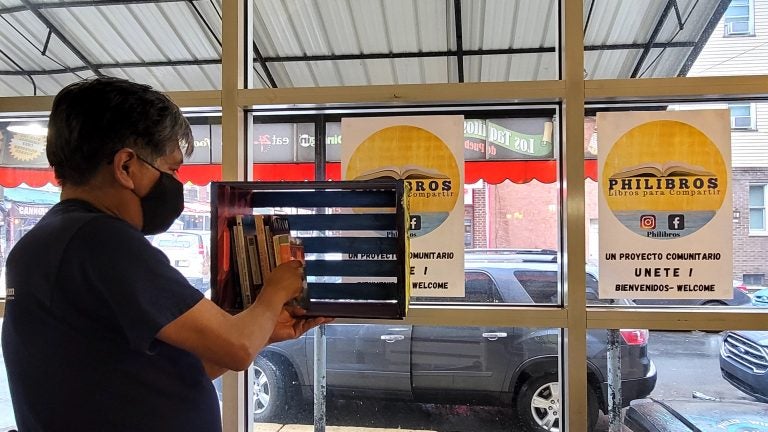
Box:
253;357;288;423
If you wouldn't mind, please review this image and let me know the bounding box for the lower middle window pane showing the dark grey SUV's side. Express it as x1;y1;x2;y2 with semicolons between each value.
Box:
254;324;562;432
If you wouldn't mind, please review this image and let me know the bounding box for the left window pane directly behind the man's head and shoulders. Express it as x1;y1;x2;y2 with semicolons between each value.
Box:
0;116;216;297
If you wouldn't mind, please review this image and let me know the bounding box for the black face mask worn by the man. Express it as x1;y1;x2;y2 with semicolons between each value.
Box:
134;157;184;235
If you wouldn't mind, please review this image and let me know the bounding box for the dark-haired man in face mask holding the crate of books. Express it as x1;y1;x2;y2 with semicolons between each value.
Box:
2;78;329;432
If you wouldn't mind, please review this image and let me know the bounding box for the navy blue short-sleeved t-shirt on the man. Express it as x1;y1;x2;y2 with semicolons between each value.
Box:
2;200;221;432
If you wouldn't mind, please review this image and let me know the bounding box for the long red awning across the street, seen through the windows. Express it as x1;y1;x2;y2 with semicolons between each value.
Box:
0;159;597;188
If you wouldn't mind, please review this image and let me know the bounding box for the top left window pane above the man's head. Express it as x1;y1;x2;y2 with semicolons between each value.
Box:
0;1;221;96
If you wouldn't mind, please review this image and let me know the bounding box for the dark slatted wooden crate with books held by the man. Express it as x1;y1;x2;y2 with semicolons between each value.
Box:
211;180;409;319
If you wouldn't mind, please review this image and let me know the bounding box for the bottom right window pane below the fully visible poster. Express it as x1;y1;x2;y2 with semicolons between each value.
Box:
596;330;768;432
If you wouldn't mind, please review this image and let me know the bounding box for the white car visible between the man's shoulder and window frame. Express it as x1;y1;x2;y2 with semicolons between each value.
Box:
150;231;211;293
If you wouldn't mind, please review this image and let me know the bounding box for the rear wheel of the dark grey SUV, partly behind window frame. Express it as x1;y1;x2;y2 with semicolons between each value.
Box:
517;374;598;432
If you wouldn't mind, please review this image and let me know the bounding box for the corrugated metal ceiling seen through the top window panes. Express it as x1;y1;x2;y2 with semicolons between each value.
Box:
0;0;729;96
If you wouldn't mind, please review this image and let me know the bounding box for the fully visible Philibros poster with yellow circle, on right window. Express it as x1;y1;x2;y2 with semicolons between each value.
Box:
597;110;733;299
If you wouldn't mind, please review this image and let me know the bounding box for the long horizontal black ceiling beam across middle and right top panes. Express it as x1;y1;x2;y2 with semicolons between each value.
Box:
264;42;696;63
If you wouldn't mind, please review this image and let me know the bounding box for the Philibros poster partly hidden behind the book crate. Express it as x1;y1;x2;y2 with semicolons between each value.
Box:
341;116;464;297
